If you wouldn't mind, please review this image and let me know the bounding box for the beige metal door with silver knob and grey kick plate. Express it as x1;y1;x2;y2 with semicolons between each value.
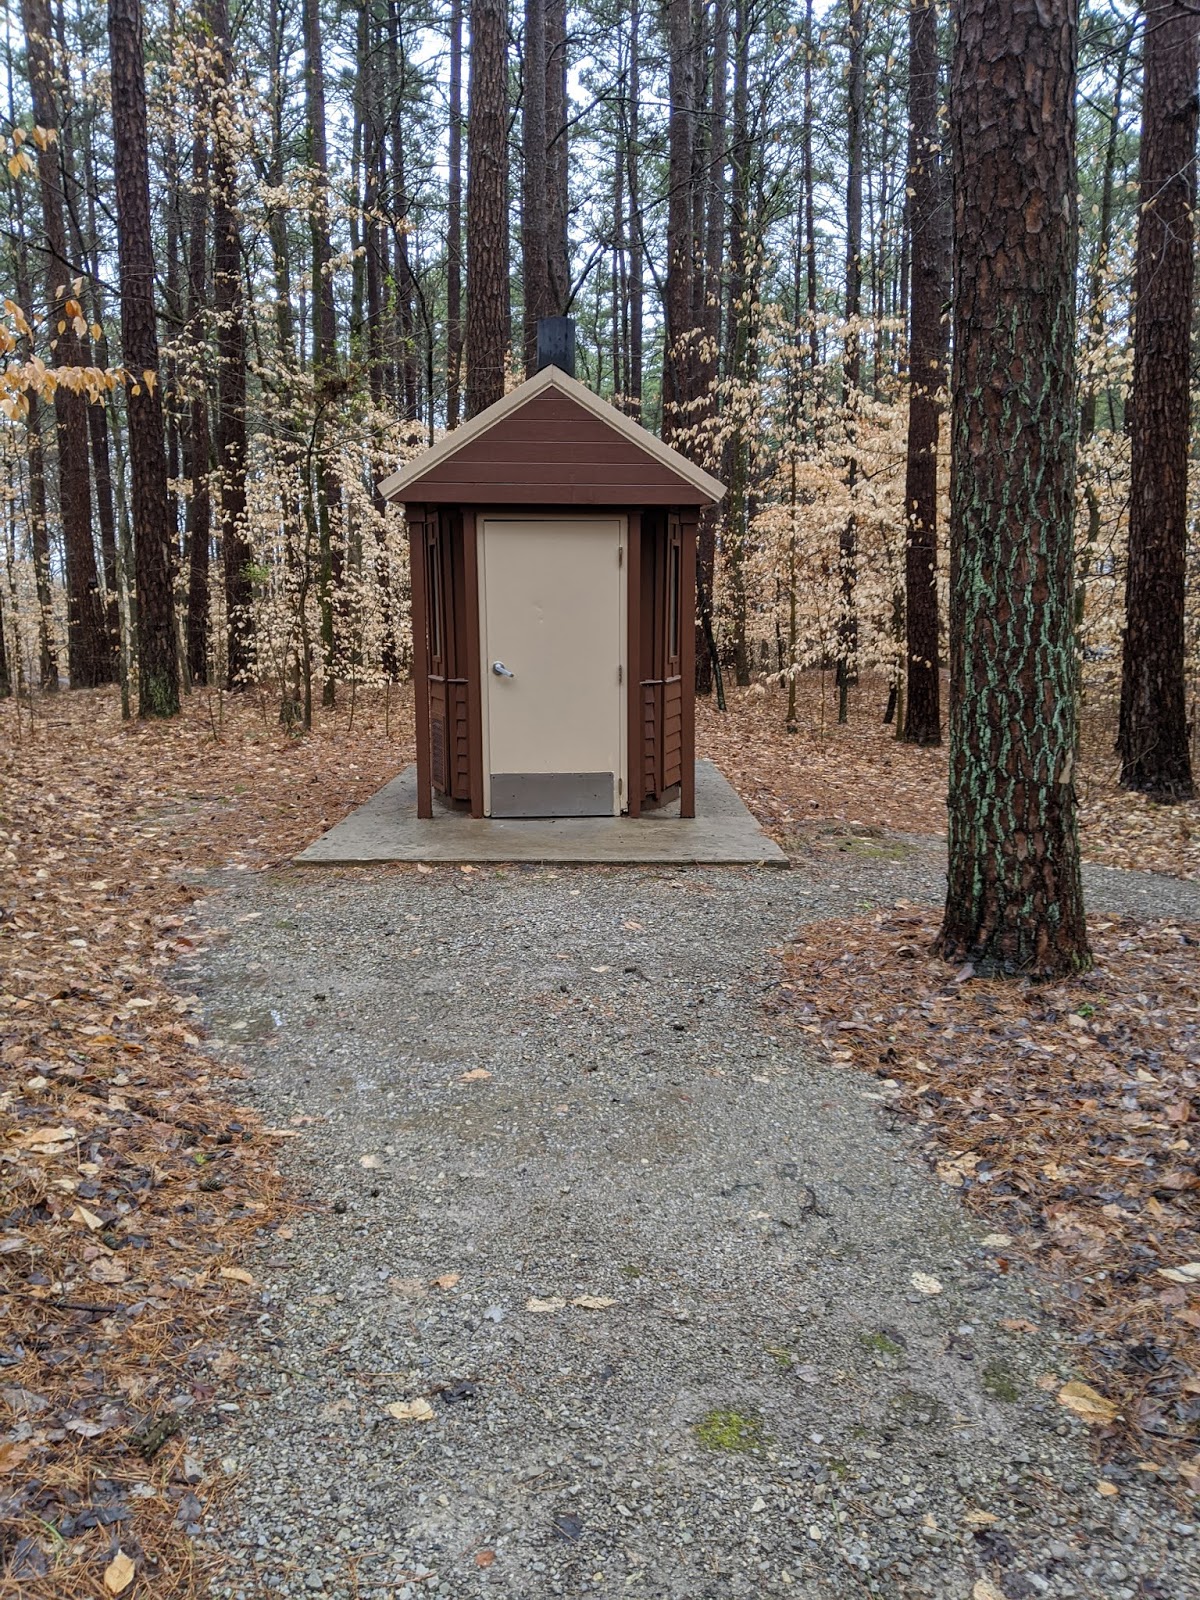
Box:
478;517;626;816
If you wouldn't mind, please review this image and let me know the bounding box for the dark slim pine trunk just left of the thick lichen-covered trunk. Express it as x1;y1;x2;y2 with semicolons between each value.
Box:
904;0;949;744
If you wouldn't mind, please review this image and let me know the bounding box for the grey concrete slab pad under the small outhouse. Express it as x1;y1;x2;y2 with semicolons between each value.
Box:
296;762;787;867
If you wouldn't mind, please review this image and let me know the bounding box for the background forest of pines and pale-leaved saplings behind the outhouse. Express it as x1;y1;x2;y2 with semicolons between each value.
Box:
0;0;1200;738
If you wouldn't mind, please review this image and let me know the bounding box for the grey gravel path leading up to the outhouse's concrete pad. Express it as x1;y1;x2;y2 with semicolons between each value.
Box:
181;840;1200;1600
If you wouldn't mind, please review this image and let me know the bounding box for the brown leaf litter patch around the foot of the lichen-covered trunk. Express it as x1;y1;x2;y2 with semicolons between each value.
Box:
771;904;1200;1488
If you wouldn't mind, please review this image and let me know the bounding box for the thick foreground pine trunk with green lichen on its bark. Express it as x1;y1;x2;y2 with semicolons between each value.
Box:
939;0;1090;976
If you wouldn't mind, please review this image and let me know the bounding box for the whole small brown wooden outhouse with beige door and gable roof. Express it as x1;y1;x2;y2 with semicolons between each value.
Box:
381;366;725;818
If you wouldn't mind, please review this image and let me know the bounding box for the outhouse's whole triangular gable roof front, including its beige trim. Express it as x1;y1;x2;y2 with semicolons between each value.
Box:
379;366;725;506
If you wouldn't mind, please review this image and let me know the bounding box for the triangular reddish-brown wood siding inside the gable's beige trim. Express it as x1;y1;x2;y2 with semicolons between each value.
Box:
403;390;694;506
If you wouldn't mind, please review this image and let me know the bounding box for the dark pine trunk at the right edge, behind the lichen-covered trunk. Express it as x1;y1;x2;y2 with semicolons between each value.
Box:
1118;0;1200;803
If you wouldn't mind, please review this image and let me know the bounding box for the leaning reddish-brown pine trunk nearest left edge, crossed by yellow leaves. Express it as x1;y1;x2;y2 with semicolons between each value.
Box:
21;0;114;688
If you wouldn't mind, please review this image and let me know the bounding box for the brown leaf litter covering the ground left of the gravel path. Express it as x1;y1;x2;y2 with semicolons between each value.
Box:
0;691;411;1600
